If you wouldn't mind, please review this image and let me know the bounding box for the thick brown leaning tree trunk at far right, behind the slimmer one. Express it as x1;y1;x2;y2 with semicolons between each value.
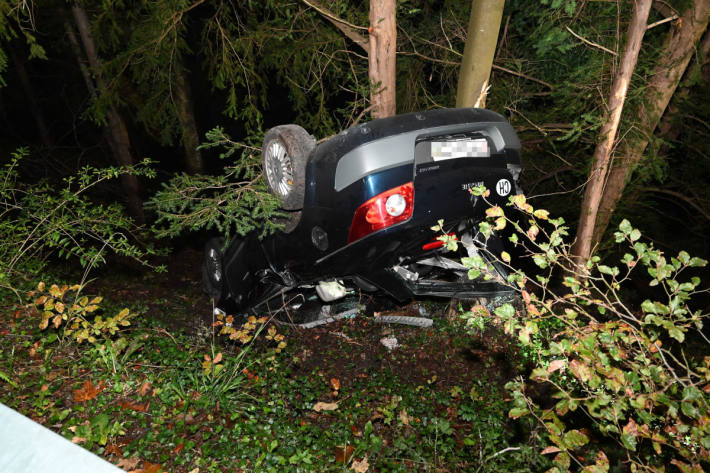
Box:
593;0;710;242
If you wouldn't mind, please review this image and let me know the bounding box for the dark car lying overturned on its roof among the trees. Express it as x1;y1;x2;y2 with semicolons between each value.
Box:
203;108;521;314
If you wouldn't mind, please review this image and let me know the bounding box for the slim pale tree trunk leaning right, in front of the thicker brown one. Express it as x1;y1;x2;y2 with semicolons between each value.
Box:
572;0;652;264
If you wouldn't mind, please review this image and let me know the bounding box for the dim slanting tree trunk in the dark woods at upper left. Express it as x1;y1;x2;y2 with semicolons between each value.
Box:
72;5;145;224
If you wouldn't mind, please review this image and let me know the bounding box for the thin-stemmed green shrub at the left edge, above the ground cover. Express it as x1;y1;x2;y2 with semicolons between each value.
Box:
0;149;159;297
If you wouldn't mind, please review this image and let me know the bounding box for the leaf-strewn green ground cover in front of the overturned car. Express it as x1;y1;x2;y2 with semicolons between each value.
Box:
0;272;548;473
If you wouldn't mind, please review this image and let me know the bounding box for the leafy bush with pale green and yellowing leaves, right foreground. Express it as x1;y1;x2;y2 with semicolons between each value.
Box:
454;189;710;473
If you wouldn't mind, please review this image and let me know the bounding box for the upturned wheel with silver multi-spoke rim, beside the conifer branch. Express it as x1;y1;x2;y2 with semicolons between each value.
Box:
261;125;316;210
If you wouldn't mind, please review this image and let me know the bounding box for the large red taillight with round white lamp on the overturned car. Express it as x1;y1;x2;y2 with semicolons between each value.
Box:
348;182;414;243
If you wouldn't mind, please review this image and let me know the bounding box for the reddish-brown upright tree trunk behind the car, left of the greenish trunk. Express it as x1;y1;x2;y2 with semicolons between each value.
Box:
368;0;397;118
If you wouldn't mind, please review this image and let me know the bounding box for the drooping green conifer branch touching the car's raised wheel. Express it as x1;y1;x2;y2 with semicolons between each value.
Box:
150;128;282;237
